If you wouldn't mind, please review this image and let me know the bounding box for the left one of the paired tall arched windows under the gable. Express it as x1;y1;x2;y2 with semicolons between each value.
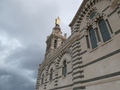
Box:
89;28;97;49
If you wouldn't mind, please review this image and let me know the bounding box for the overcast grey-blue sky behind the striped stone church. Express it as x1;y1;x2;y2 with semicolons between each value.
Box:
0;0;82;90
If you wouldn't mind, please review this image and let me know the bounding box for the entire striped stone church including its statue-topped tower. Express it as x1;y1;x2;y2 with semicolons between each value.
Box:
36;0;120;90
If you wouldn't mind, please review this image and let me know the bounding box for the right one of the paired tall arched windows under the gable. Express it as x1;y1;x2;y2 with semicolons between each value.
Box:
98;19;111;42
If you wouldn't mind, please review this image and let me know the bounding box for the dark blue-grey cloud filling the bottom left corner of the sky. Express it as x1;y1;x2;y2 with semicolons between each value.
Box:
0;72;35;90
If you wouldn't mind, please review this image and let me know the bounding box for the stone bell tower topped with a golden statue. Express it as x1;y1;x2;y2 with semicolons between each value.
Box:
45;17;66;57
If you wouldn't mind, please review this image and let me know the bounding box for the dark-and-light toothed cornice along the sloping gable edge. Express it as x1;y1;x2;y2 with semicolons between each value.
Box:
69;0;108;29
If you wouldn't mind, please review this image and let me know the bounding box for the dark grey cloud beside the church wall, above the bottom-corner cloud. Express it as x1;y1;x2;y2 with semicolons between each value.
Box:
5;44;44;78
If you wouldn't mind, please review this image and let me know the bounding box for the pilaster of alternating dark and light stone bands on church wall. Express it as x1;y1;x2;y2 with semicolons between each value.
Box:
72;38;84;90
